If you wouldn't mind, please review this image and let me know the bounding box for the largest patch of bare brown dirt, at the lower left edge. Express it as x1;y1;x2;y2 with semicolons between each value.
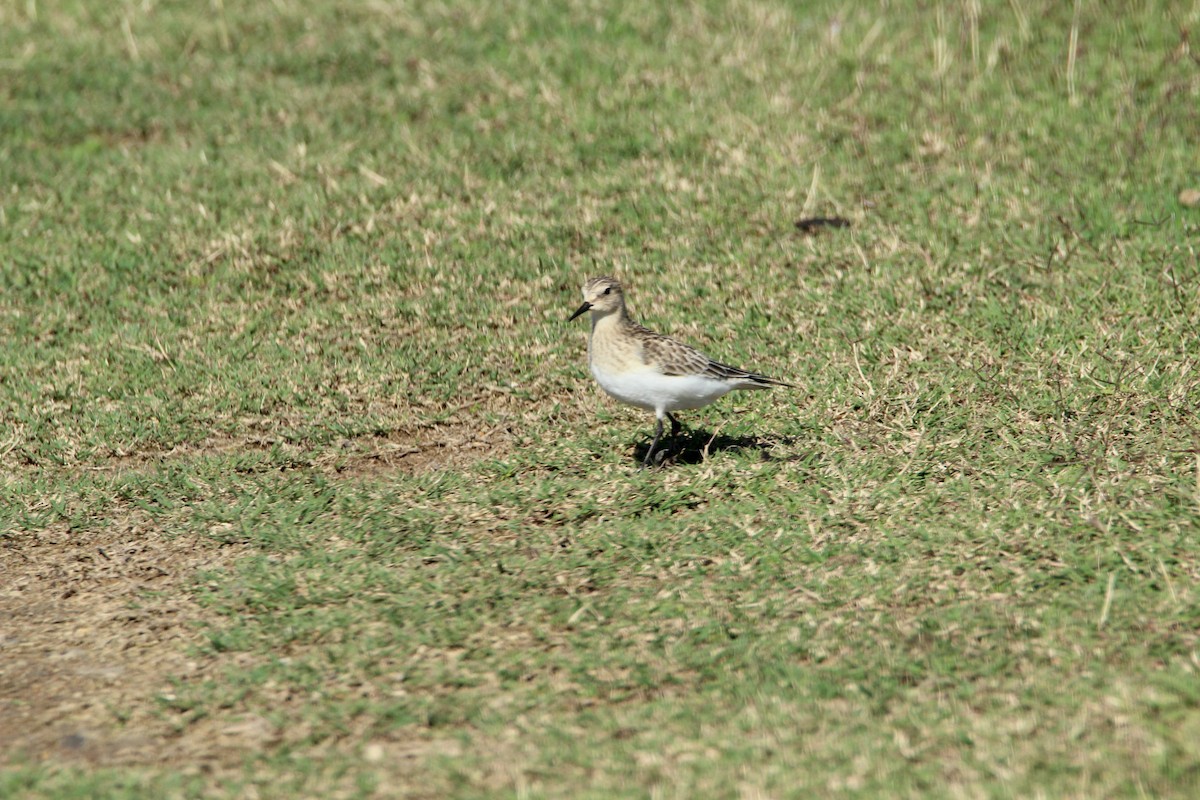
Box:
0;513;245;765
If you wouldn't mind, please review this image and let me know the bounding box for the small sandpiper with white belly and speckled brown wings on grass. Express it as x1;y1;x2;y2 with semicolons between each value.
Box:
568;277;792;468
